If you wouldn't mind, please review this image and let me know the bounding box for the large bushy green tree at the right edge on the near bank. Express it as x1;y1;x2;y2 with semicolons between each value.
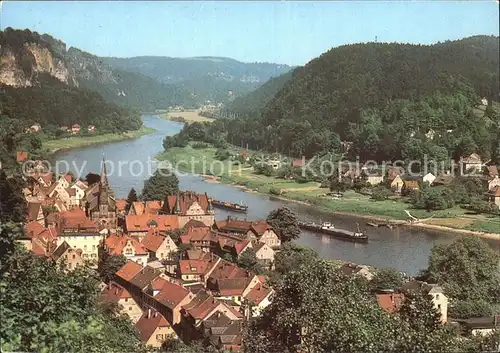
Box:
427;236;500;304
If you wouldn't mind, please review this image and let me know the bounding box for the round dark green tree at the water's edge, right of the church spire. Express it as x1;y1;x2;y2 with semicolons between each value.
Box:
141;169;179;201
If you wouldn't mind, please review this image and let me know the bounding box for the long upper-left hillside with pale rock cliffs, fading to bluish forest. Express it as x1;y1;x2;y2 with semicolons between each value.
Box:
0;28;196;110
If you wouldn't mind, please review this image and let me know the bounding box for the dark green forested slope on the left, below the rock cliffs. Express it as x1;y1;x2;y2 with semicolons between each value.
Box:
0;74;142;133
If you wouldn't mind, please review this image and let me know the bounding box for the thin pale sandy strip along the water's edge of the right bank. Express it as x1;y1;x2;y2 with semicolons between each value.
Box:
200;175;500;241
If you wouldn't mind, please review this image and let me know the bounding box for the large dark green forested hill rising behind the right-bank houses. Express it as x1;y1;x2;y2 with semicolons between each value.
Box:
219;36;500;159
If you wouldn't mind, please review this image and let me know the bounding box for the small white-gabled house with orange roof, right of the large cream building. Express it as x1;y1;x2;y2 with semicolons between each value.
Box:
104;234;149;266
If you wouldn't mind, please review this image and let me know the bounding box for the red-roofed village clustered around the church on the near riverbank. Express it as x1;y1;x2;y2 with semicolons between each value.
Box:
17;160;500;351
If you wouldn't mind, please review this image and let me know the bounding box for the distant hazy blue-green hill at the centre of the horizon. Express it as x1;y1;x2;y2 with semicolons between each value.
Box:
102;56;291;103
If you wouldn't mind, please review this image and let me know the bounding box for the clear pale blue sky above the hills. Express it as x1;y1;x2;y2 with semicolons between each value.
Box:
0;0;499;65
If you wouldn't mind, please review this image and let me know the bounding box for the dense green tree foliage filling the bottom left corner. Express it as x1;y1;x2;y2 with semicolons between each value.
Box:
0;249;144;352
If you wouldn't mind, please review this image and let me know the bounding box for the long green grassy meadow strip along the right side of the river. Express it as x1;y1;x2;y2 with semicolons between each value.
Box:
157;146;500;236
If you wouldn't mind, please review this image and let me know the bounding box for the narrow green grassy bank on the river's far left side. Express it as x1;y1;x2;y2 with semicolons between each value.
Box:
42;126;155;154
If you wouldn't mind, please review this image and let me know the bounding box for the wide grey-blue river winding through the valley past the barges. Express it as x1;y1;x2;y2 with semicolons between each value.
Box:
55;115;500;275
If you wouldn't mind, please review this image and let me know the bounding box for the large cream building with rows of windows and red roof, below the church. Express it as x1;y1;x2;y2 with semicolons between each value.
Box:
47;208;102;262
